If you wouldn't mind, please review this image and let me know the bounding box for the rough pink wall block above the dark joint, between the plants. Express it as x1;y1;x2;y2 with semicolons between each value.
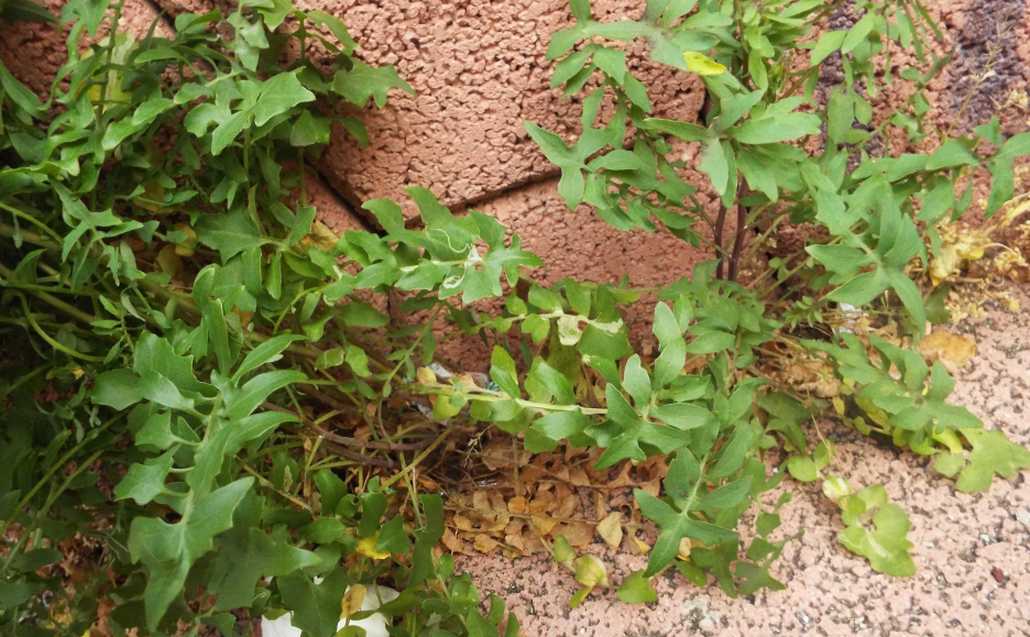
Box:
305;0;702;213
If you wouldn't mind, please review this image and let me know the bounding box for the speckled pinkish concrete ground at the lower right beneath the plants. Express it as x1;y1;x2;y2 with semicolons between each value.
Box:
461;287;1030;637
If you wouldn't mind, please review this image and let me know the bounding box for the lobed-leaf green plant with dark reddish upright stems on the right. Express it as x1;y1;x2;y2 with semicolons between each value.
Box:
526;0;1030;590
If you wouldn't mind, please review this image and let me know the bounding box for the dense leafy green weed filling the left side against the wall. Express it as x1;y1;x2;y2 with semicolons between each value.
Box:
0;0;515;637
